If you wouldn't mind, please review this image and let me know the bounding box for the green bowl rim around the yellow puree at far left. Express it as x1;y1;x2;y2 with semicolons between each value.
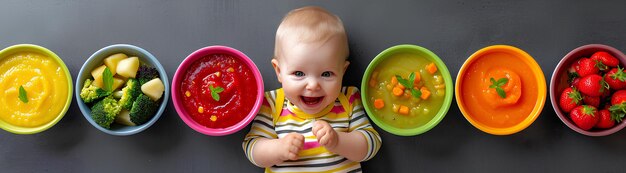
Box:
0;44;73;134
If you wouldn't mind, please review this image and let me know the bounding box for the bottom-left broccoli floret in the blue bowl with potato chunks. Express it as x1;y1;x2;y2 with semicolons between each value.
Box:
91;97;122;129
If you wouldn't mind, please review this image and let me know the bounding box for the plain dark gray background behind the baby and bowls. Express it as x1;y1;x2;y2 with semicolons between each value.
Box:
0;0;626;172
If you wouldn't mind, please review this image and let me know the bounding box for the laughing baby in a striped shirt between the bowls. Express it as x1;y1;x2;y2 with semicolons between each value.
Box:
242;7;382;172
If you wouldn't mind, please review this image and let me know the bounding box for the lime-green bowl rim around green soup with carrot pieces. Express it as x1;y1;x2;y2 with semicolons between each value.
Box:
361;45;454;136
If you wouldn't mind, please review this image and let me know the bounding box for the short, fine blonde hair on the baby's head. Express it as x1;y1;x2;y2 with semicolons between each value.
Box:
274;6;349;59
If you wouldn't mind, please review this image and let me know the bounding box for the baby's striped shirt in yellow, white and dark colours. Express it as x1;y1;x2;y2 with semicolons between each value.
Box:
242;87;382;172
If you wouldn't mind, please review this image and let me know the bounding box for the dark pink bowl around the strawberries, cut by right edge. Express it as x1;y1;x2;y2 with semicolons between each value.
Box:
550;44;626;136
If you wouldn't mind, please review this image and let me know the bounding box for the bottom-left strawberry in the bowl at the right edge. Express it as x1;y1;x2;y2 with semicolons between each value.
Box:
569;105;599;130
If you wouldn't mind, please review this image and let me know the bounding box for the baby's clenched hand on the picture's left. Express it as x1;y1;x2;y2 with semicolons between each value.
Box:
277;132;304;161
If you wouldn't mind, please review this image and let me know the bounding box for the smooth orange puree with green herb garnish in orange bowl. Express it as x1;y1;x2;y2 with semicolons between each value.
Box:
460;52;543;128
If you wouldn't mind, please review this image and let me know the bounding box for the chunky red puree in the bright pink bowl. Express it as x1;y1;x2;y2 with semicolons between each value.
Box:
180;54;257;128
